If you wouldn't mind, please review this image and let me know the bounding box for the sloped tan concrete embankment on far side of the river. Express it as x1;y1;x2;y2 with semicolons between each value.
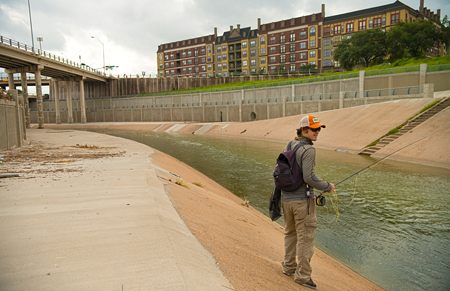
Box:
56;97;450;168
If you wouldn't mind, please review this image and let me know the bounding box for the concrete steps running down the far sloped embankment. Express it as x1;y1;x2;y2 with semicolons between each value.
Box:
359;97;450;156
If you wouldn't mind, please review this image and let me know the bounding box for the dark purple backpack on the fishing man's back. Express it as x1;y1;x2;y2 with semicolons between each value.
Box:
273;142;307;192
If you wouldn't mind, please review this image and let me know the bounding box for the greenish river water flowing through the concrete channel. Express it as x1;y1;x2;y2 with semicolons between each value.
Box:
89;130;450;291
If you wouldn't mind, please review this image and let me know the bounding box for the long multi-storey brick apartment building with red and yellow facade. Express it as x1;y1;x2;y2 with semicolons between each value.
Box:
157;0;443;77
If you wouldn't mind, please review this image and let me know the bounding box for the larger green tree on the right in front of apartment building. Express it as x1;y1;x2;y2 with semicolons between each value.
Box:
386;19;442;62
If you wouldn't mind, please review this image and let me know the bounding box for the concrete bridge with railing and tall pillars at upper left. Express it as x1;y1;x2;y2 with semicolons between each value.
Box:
0;35;112;128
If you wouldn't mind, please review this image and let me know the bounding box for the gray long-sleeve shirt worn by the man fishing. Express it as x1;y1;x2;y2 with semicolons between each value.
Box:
282;140;331;201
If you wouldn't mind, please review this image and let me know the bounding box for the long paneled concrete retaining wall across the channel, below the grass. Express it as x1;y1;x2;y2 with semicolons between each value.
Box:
31;89;433;123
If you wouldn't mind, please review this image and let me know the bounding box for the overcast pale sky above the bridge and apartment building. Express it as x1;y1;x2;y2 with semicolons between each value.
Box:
0;0;450;76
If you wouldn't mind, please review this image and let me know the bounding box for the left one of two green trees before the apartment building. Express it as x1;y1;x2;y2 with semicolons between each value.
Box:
334;28;387;70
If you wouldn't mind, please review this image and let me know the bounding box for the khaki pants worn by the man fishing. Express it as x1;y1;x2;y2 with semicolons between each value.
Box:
281;199;317;284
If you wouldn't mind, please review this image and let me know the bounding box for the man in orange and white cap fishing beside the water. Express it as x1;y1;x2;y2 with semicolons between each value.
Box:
281;115;334;289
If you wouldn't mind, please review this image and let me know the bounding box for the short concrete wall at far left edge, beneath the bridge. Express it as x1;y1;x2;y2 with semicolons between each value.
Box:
0;90;25;150
